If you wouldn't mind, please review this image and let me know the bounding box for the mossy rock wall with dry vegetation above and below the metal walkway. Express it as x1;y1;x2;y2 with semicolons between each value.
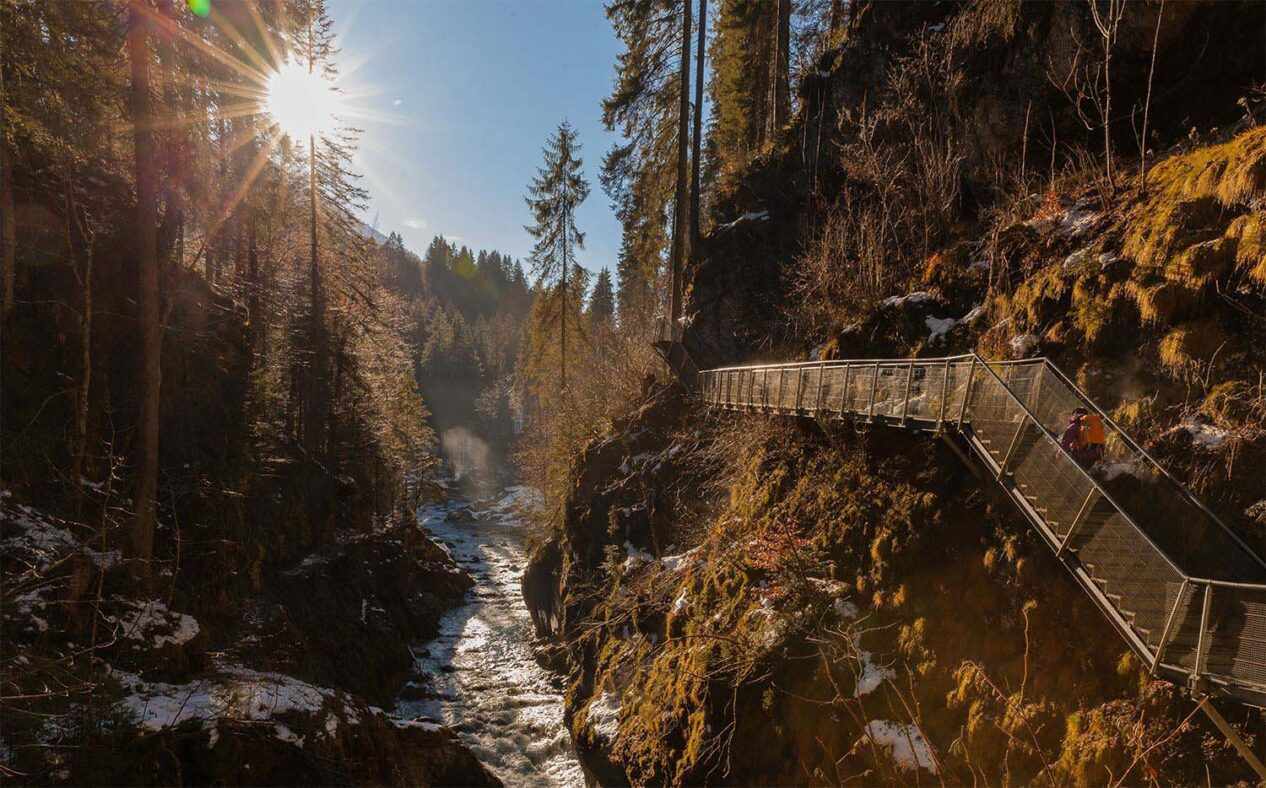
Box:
524;0;1266;785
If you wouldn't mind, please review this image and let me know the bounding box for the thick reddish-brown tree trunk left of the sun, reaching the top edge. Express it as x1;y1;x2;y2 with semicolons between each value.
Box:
128;0;162;580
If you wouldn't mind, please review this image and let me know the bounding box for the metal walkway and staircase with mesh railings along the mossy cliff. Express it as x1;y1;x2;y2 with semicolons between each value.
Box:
699;353;1266;706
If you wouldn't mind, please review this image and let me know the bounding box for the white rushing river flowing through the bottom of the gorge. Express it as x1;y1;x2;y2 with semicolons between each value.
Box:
398;488;585;787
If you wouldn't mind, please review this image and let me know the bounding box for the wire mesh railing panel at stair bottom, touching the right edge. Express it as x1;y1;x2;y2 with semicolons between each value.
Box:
1204;587;1266;685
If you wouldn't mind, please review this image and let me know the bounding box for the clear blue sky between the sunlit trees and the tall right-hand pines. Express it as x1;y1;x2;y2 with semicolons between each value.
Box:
329;0;620;271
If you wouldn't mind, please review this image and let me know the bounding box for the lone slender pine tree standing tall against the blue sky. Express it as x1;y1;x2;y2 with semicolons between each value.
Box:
525;120;589;391
